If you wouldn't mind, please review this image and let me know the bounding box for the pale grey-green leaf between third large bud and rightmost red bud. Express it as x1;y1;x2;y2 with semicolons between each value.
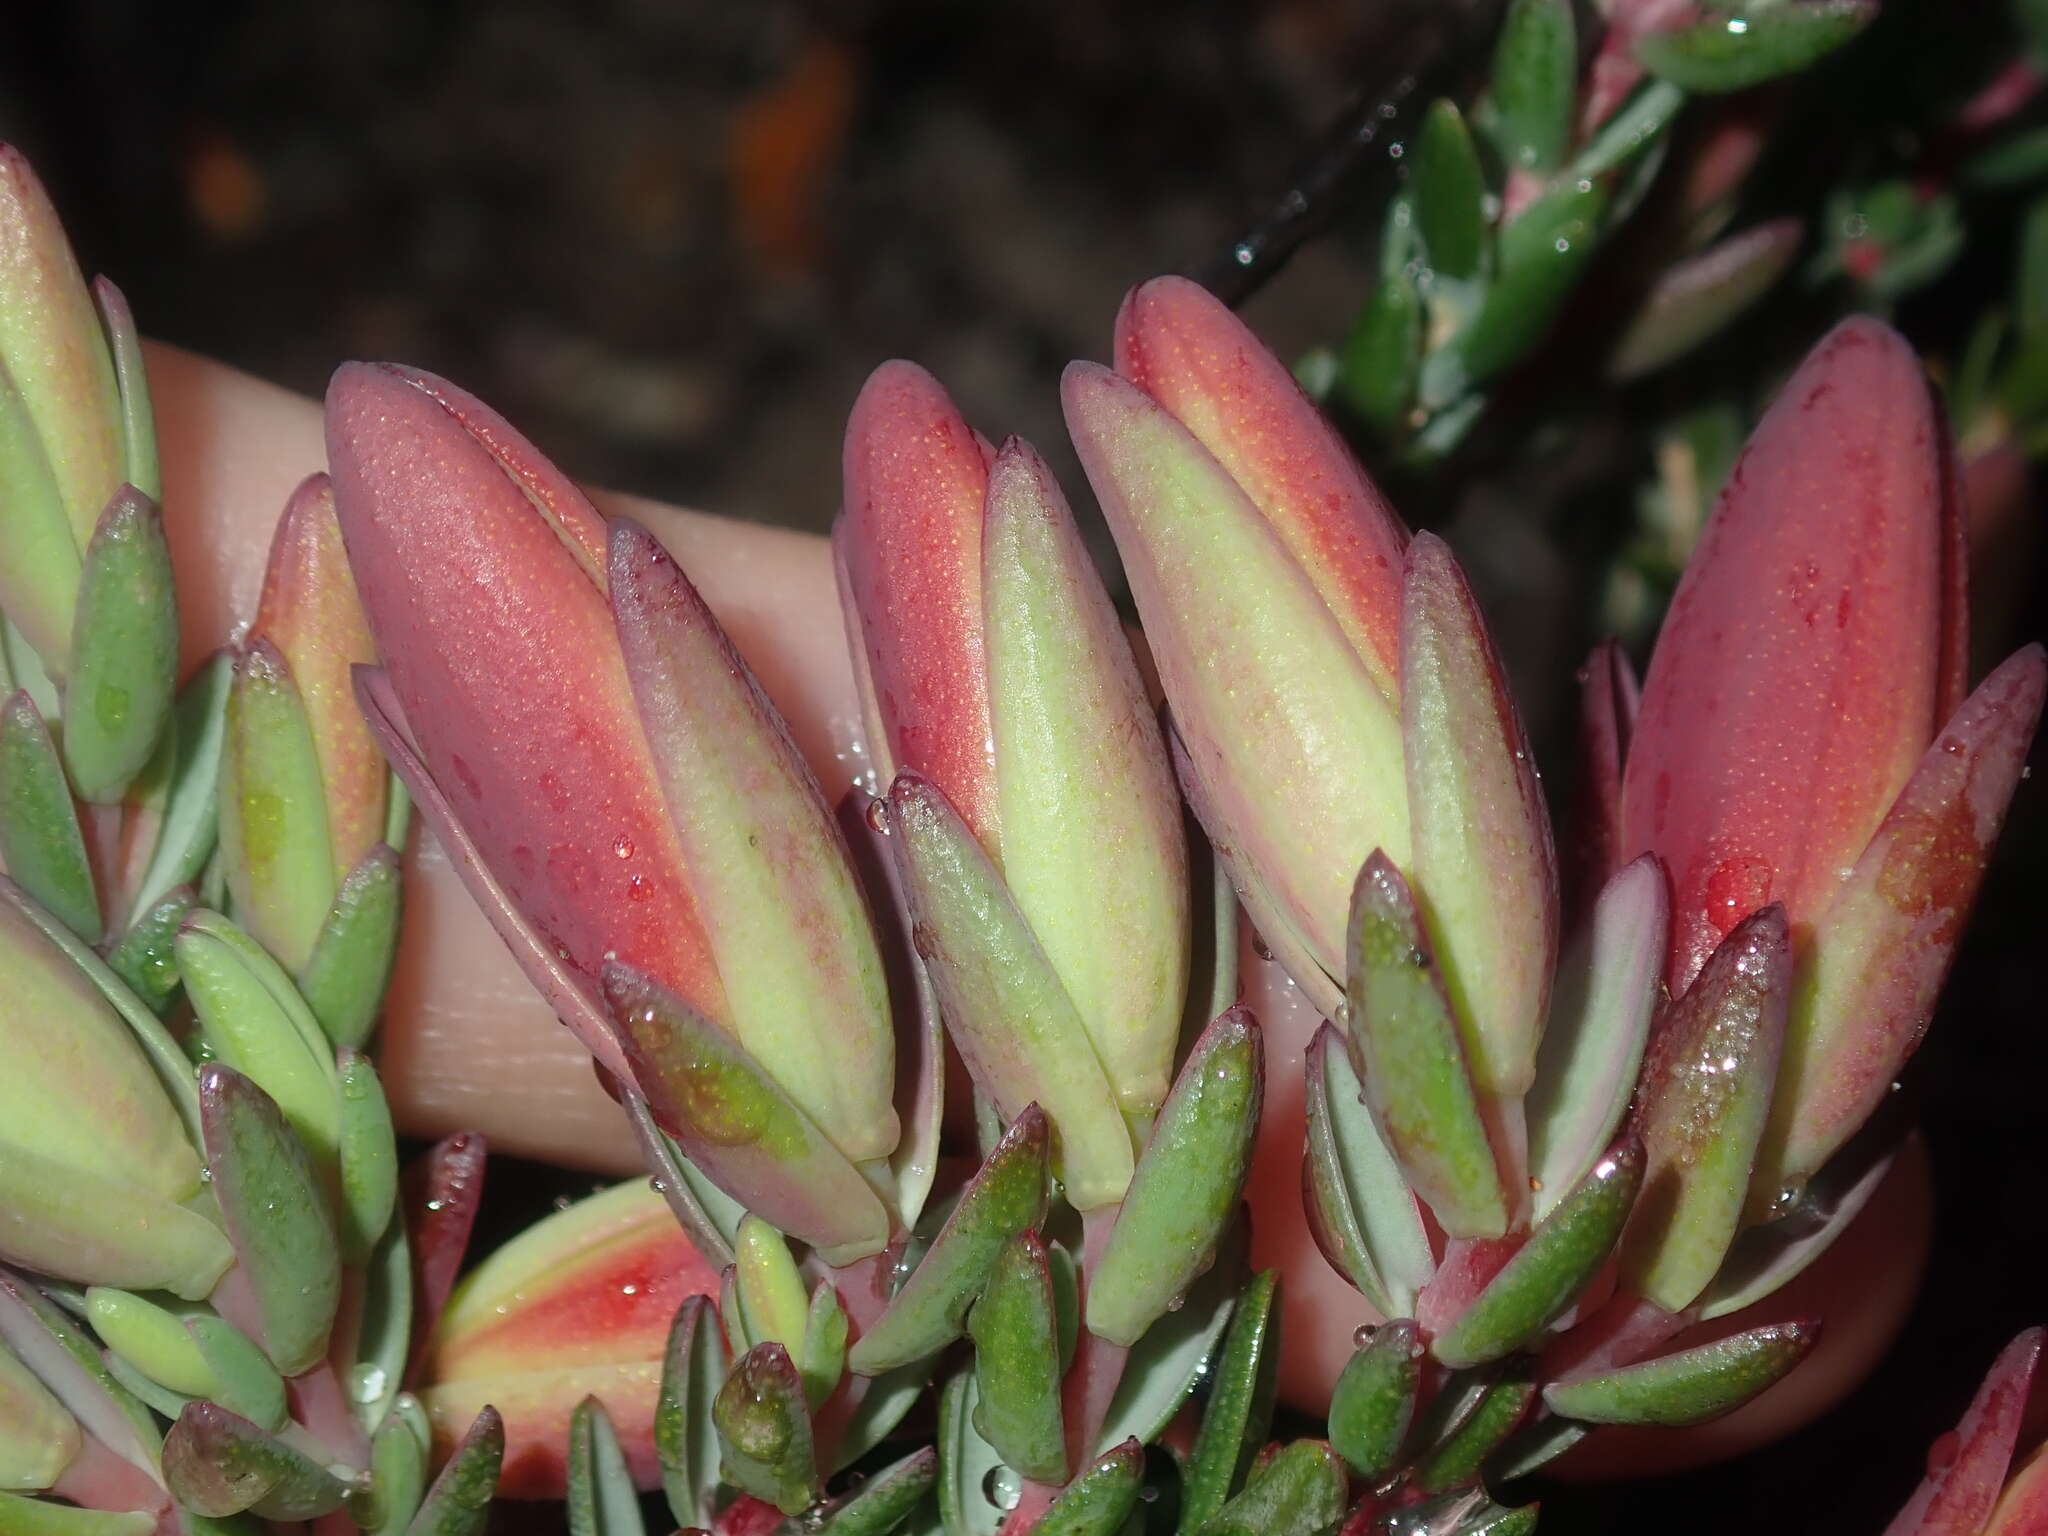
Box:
1528;856;1671;1221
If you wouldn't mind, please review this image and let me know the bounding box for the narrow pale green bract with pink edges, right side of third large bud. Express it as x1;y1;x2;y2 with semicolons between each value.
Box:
1401;532;1559;1098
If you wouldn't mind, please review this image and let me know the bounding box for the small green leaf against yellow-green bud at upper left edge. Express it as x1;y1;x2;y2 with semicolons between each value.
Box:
63;485;178;805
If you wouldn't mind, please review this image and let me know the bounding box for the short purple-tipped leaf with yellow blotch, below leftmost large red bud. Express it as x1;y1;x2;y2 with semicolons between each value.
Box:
604;961;889;1264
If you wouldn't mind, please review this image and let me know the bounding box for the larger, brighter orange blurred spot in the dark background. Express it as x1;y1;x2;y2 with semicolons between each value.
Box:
731;39;860;272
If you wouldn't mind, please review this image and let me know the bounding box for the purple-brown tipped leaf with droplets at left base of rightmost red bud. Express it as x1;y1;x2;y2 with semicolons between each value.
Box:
1622;907;1792;1313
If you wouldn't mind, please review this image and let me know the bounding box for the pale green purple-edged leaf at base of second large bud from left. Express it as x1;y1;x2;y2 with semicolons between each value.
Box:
889;772;1133;1210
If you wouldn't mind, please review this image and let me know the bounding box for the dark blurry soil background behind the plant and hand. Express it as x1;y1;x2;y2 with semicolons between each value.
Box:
0;0;2048;1536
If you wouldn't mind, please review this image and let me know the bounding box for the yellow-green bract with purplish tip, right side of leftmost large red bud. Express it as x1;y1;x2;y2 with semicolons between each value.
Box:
610;520;897;1163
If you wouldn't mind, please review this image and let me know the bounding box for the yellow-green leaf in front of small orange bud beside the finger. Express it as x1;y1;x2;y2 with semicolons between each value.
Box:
219;639;336;971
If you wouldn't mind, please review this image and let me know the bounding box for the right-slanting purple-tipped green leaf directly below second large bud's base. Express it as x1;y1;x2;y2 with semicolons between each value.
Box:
846;1106;1051;1376
